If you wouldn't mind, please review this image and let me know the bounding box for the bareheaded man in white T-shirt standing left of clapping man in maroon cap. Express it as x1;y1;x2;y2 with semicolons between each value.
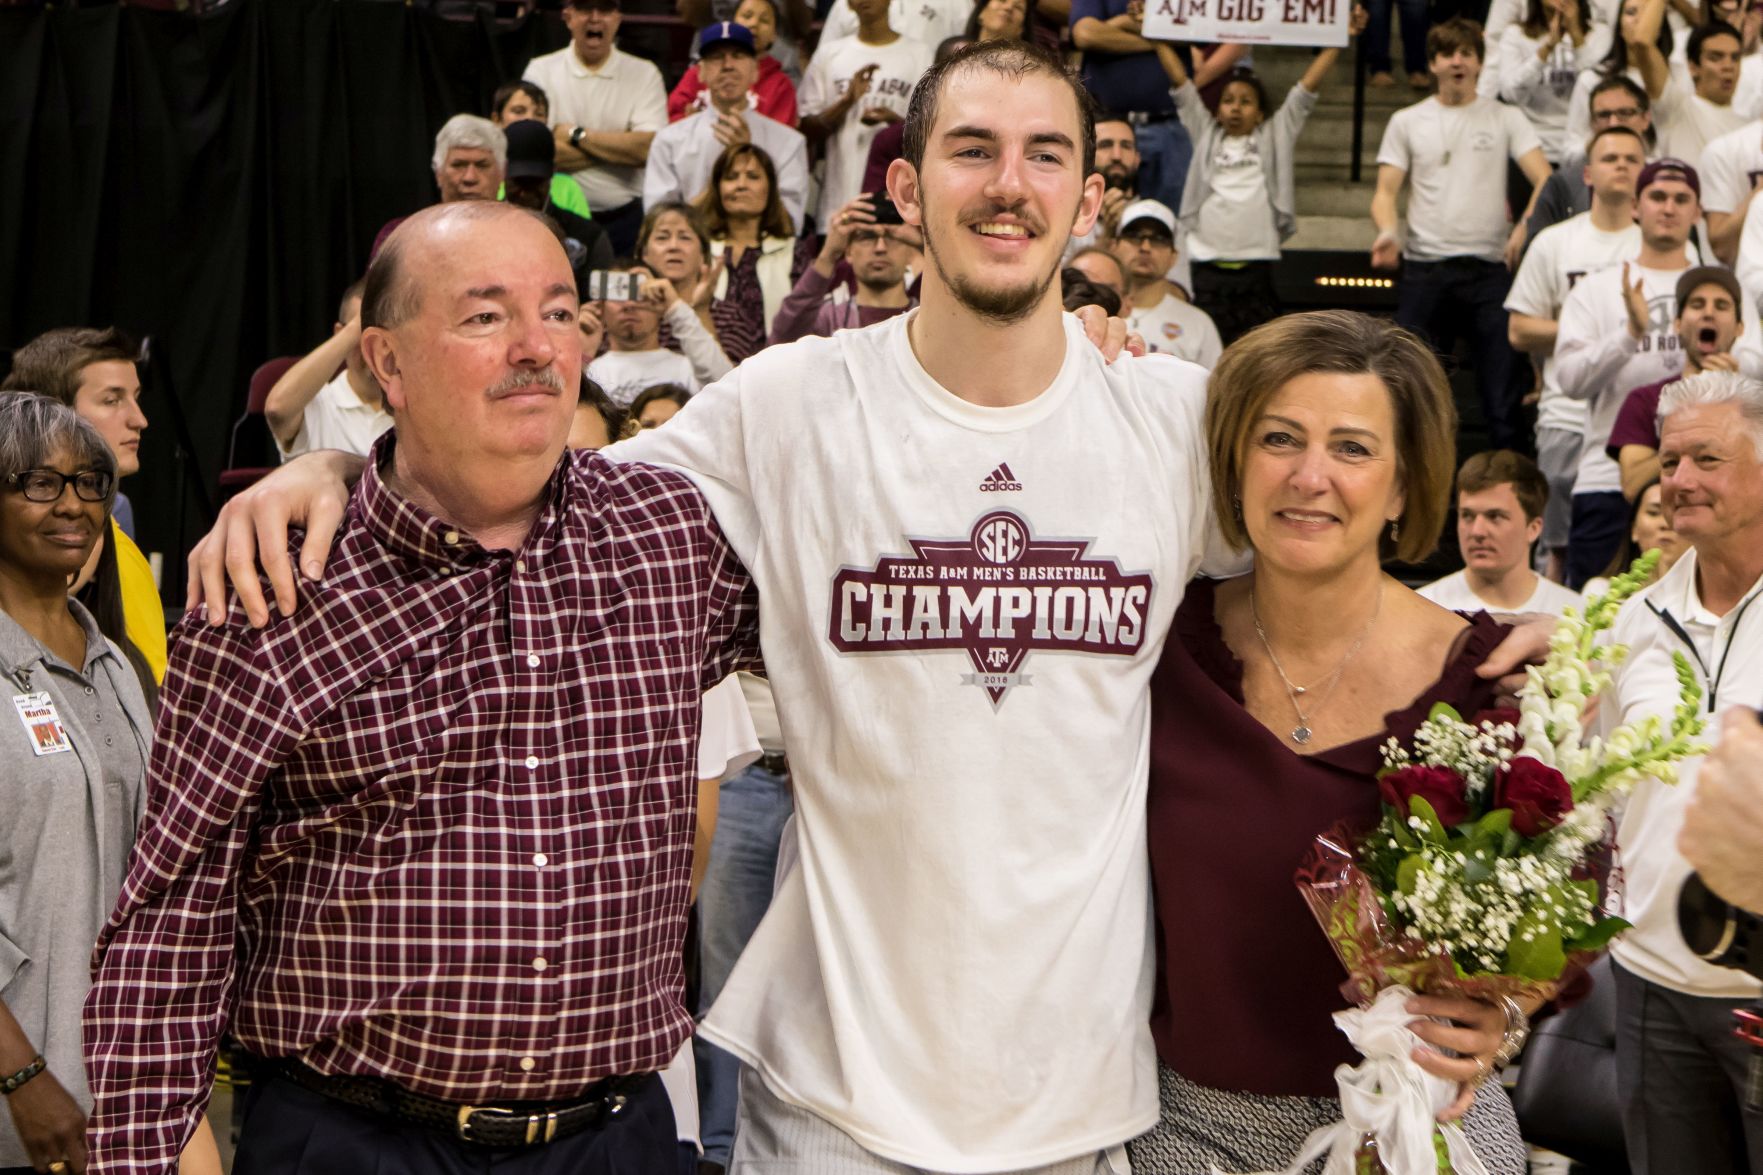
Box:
1506;125;1647;577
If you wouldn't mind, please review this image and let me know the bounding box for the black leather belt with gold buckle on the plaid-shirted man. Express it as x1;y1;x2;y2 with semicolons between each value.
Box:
275;1060;654;1149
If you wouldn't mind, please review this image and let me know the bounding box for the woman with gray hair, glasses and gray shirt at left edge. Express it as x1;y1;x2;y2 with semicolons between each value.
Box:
0;392;152;1171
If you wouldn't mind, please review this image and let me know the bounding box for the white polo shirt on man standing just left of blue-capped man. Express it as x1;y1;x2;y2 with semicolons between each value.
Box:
525;44;666;213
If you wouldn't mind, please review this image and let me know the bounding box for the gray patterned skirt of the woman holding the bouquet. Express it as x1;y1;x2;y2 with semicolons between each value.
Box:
1127;1066;1529;1175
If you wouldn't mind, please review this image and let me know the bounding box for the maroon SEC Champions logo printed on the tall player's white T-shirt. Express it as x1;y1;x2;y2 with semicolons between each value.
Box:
827;510;1151;707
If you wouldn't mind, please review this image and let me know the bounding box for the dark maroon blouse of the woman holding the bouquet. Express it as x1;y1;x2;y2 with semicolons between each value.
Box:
1149;580;1506;1097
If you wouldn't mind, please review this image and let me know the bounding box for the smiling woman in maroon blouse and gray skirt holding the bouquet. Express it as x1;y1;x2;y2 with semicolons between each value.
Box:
1132;311;1525;1175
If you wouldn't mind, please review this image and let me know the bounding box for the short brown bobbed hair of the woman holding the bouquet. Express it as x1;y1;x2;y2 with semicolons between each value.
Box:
1206;311;1456;563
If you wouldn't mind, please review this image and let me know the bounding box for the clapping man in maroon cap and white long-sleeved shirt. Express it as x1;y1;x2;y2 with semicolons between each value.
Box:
1555;159;1701;589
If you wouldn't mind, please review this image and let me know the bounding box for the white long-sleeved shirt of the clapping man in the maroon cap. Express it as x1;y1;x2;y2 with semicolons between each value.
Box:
1555;265;1684;496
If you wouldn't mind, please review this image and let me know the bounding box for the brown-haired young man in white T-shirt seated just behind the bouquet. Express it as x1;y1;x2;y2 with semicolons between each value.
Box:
1419;448;1580;614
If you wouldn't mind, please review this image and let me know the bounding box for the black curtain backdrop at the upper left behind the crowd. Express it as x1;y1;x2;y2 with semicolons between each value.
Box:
0;0;680;595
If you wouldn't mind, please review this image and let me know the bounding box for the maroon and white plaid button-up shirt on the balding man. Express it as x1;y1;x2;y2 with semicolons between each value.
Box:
85;436;758;1171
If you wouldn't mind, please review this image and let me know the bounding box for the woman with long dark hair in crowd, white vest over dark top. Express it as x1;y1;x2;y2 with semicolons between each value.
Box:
698;143;815;363
